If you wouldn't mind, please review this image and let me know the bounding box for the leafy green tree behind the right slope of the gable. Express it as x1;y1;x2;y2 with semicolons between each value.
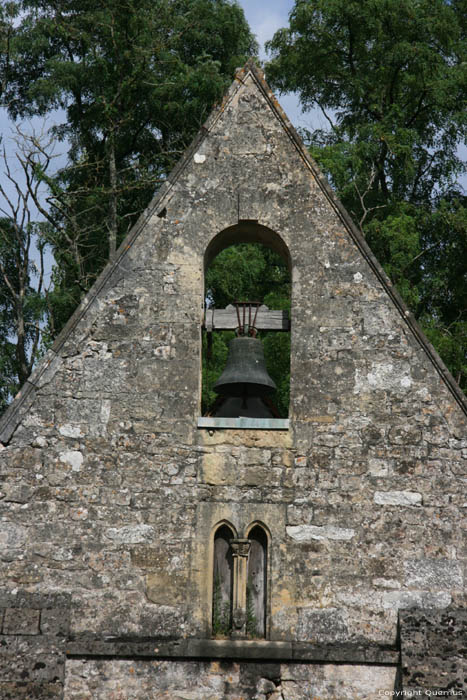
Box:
267;0;467;388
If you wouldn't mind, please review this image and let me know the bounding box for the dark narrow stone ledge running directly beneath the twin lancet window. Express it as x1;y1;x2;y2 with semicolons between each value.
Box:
66;635;399;666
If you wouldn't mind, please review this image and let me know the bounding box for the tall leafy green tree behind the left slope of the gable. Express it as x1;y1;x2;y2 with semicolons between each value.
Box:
3;0;256;331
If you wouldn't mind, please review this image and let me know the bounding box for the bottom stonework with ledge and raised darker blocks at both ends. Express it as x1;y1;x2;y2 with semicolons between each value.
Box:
0;591;467;700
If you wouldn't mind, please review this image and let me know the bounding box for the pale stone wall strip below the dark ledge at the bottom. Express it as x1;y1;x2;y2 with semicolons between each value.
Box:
65;659;396;700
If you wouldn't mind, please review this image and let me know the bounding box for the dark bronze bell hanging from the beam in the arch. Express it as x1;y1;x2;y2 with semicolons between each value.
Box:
213;336;276;398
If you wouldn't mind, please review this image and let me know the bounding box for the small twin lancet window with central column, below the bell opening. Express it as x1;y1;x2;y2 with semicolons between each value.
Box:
212;524;268;639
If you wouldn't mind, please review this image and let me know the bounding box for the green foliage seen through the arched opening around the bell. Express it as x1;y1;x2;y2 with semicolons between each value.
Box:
202;243;290;417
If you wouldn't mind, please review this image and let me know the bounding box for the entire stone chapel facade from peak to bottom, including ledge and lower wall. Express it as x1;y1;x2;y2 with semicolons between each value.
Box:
0;62;467;700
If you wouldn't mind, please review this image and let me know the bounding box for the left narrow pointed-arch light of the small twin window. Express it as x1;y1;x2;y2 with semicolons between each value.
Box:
212;524;235;637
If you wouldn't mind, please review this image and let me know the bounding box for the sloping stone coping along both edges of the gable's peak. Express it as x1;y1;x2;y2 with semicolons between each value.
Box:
0;60;467;444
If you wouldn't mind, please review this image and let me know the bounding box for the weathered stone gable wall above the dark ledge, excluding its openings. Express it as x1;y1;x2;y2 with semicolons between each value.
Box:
0;64;467;696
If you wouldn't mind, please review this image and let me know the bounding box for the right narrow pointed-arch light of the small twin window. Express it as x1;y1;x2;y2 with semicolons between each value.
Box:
246;525;268;637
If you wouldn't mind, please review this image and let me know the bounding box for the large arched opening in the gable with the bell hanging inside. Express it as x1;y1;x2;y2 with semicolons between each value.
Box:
202;222;291;419
